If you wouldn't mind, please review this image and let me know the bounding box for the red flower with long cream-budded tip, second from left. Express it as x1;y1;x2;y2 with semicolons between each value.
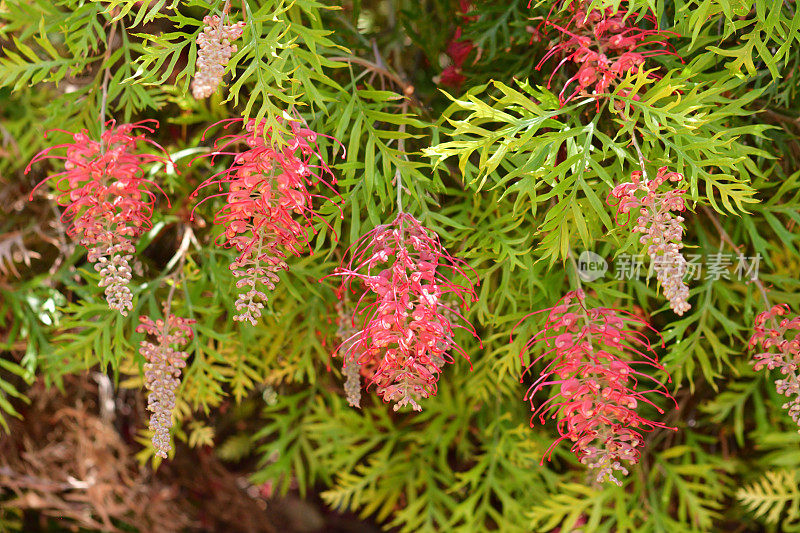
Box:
192;119;335;325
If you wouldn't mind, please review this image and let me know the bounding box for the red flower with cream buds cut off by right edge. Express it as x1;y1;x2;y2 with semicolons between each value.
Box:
750;304;800;425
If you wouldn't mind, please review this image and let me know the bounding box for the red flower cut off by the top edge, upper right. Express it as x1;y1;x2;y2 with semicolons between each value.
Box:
536;1;675;104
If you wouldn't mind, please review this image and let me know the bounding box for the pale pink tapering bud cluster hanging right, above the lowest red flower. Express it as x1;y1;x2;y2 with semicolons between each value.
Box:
611;167;692;315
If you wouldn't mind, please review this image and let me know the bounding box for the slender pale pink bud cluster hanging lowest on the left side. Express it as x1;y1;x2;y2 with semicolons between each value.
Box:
136;309;195;459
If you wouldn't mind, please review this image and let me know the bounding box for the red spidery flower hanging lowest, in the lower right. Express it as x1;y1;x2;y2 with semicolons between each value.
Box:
517;290;677;485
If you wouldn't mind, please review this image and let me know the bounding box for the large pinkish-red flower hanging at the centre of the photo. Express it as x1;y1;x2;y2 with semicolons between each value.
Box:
333;213;478;411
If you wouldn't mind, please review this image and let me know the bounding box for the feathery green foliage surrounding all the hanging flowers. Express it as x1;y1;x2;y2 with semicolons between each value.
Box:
0;0;800;532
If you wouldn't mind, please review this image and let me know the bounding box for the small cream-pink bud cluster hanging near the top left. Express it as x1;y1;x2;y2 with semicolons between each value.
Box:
192;15;244;99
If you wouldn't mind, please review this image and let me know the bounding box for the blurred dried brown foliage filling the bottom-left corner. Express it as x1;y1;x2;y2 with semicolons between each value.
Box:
0;377;275;533
